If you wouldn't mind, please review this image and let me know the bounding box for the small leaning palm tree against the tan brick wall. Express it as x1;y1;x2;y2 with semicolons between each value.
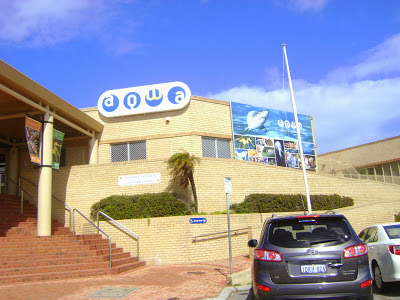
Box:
167;151;200;212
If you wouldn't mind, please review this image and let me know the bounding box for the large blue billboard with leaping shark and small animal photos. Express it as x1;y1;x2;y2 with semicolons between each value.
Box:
231;102;316;169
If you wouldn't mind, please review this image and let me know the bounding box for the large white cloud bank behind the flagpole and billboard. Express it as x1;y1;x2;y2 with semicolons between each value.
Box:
208;36;400;154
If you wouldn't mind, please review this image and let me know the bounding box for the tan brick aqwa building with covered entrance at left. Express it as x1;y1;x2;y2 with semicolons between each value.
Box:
0;61;400;264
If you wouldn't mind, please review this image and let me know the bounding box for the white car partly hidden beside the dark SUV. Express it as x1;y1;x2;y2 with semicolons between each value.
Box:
358;222;400;292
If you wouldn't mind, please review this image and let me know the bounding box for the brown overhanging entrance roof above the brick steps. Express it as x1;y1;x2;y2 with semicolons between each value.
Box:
0;60;103;142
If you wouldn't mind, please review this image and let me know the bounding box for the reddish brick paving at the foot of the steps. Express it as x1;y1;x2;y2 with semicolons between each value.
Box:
0;255;251;300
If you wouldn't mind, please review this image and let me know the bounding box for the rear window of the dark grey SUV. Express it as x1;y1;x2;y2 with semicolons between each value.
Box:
268;217;351;248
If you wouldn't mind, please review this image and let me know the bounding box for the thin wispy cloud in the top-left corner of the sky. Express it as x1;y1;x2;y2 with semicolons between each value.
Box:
0;0;140;55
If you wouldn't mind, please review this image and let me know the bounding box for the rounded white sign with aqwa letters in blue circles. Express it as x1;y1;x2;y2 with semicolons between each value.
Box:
97;82;191;118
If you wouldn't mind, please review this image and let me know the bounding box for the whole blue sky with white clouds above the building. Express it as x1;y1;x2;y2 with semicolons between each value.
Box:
0;0;400;154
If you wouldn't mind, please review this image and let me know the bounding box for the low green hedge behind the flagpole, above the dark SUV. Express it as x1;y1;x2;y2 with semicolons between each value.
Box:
230;194;354;213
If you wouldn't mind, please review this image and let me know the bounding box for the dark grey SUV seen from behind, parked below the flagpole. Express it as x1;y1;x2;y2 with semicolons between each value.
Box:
248;214;373;299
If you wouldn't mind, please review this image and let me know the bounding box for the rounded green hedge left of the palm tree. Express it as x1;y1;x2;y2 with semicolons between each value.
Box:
90;192;190;220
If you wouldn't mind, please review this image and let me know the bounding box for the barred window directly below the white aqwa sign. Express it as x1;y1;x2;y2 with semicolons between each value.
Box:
111;141;147;162
